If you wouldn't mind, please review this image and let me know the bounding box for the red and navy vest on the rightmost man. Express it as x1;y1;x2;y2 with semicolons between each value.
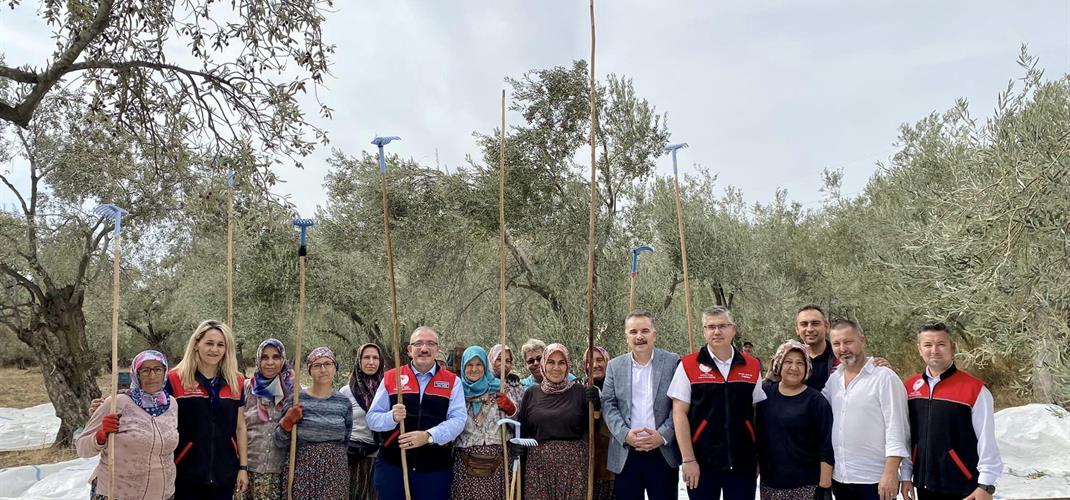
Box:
904;364;984;498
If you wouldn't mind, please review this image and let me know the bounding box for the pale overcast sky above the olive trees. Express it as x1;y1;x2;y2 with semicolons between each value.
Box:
0;0;1070;214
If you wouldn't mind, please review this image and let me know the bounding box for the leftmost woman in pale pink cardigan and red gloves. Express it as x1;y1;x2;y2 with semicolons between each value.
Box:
75;350;179;500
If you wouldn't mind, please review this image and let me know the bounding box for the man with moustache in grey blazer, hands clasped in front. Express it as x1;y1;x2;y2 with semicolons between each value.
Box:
601;309;679;500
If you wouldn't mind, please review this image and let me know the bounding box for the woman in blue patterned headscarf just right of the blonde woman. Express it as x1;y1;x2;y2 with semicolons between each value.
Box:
245;338;293;500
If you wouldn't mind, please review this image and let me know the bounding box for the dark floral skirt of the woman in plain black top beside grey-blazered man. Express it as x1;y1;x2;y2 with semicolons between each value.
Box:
524;440;587;500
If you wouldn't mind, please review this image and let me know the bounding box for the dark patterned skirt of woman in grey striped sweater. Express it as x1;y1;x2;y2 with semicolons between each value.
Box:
281;442;349;500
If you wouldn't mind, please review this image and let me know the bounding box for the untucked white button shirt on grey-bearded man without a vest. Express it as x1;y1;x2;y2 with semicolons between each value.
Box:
822;358;910;484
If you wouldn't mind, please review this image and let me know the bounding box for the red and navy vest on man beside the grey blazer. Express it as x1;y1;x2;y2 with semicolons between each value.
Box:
681;347;761;474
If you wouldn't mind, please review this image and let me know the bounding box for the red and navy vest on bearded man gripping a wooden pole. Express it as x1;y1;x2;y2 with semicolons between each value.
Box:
378;364;460;472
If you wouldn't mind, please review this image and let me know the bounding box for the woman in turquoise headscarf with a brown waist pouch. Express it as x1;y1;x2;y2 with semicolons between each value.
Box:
452;346;517;500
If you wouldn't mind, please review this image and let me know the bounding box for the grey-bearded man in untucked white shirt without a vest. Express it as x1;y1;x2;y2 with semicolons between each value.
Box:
822;320;910;500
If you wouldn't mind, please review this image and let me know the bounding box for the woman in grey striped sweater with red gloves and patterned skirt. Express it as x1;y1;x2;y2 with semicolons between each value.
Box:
275;347;353;500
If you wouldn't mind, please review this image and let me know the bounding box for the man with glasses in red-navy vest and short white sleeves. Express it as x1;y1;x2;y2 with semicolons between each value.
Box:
669;307;766;500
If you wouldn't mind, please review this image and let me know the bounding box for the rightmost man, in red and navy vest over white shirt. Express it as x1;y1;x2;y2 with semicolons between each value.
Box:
900;323;1003;500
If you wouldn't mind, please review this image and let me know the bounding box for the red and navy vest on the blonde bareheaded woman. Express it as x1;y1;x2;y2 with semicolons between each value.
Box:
166;369;245;487
